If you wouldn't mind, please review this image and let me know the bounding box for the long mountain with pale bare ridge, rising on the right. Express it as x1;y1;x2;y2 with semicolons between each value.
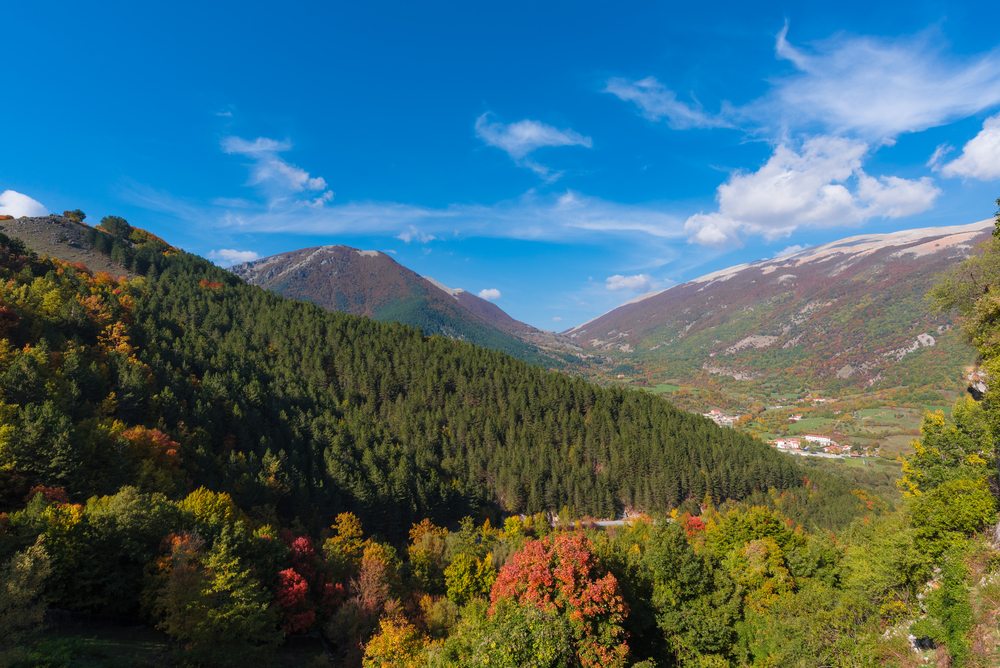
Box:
565;221;993;403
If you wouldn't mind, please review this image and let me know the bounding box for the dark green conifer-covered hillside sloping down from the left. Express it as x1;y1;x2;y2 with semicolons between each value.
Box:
0;219;801;531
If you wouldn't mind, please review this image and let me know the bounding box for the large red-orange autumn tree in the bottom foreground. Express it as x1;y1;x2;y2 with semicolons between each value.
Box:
490;532;628;668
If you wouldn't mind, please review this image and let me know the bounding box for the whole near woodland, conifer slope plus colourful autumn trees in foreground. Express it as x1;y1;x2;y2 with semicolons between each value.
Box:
0;210;1000;667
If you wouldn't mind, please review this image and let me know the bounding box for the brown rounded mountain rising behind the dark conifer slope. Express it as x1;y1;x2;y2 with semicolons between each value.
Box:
231;246;575;364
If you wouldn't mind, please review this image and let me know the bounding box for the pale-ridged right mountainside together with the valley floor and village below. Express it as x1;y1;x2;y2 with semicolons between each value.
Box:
564;221;990;460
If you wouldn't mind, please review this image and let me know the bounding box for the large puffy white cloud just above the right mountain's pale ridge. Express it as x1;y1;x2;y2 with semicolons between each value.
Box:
684;136;940;246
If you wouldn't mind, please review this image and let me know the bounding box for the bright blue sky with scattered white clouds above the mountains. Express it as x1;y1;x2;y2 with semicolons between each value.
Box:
0;1;1000;330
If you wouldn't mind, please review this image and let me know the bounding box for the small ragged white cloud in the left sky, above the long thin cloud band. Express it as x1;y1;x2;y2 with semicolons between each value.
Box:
222;137;333;208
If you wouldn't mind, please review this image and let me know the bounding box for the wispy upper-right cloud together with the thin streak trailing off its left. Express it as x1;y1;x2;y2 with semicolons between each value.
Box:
604;24;1000;143
